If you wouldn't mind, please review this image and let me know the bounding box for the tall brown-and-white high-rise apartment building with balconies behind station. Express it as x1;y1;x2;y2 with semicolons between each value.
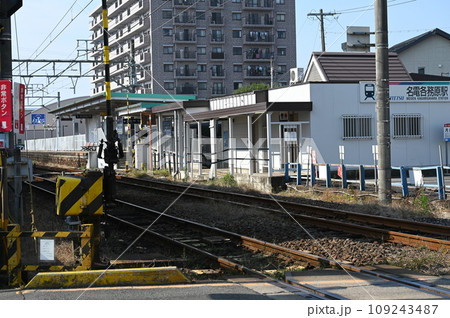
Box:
90;0;296;99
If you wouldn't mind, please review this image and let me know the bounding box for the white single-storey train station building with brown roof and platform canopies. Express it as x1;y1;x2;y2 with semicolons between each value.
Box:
26;52;450;190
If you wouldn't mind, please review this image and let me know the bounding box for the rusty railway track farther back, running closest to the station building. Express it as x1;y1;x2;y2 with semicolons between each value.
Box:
118;177;450;251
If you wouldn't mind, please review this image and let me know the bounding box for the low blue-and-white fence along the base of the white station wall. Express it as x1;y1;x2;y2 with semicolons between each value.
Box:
284;162;450;200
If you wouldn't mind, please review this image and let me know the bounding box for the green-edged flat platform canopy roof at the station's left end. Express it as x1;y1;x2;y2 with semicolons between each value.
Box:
51;92;196;116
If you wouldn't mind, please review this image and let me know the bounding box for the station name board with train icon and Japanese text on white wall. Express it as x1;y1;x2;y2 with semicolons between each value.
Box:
359;82;450;103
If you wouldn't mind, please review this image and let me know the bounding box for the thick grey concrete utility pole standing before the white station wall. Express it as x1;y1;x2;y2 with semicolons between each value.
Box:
375;0;392;204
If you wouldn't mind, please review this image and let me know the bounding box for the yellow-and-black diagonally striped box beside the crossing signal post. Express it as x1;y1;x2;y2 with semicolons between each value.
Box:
56;171;103;216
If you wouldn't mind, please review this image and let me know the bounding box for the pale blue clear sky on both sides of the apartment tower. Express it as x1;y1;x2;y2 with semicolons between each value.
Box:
11;0;450;104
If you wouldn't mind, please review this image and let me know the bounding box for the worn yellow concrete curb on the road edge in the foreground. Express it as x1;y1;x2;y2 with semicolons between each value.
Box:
25;267;189;289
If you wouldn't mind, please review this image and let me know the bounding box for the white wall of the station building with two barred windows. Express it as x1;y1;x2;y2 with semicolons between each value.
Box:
269;82;450;166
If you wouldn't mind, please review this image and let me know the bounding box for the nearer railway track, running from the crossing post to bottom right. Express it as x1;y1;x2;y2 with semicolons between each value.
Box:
28;175;450;299
